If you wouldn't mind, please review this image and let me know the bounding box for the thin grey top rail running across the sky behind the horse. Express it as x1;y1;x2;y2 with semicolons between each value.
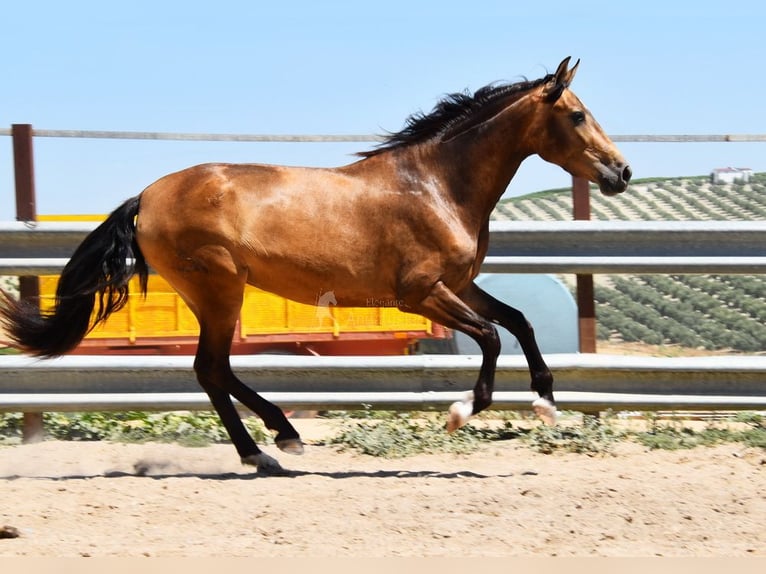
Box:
0;128;766;143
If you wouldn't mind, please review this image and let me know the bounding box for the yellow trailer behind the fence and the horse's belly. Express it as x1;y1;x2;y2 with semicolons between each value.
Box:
39;215;449;355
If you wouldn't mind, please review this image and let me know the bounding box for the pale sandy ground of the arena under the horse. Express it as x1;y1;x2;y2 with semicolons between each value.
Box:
0;419;766;557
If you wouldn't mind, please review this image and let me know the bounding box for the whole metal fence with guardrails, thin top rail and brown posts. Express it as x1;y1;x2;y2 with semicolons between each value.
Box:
0;125;766;436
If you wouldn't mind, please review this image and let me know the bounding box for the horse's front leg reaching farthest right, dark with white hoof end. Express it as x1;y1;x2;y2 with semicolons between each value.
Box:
458;283;556;424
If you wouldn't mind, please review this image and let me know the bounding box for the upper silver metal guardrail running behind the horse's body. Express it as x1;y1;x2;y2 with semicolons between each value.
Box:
0;221;766;275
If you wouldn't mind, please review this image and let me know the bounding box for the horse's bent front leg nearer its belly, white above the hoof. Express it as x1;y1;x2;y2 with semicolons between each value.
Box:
407;281;500;432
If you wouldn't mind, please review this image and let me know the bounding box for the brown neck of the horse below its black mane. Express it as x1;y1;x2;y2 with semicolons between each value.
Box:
430;94;533;227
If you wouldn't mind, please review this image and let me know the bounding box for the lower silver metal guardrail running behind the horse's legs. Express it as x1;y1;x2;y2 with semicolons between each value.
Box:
0;354;766;412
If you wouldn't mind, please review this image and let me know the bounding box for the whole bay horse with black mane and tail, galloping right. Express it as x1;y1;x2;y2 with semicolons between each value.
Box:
0;58;631;474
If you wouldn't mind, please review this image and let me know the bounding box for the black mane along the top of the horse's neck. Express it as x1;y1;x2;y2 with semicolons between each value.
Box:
357;74;553;157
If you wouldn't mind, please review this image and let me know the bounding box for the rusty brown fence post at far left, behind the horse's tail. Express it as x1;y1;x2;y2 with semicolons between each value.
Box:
11;124;43;443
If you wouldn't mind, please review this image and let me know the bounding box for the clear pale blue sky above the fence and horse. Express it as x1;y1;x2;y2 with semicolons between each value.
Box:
0;0;766;220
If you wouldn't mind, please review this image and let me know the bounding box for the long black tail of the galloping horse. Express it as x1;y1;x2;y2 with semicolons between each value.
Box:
0;197;149;357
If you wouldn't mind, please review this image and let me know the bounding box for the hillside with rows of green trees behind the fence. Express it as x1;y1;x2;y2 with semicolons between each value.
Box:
493;173;766;353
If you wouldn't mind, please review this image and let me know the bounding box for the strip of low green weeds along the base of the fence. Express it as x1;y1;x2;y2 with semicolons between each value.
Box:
0;410;766;458
